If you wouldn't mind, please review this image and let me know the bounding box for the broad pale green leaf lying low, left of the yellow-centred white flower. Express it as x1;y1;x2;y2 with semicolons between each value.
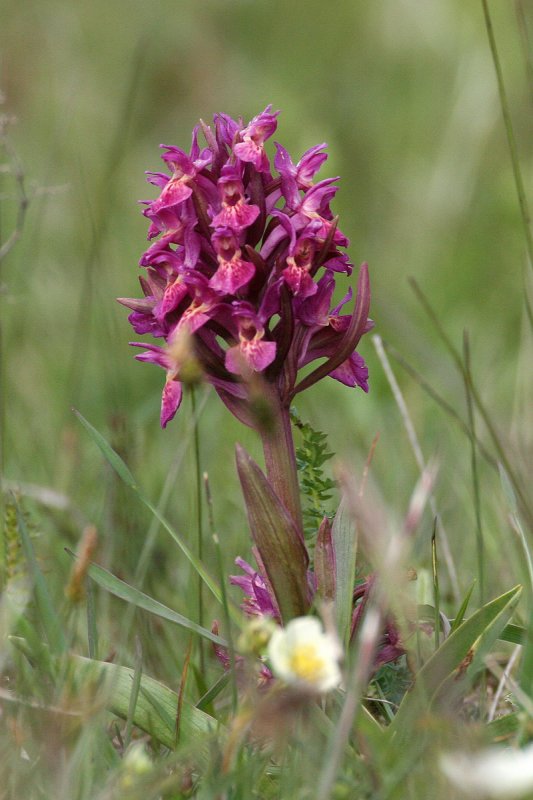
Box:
68;656;218;752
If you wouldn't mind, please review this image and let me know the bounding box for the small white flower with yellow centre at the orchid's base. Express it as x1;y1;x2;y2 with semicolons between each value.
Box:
268;617;342;692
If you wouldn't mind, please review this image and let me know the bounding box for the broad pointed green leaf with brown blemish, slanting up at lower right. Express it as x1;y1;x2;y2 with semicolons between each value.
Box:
388;586;522;740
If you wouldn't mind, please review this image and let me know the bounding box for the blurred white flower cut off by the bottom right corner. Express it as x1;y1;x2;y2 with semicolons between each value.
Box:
440;745;533;800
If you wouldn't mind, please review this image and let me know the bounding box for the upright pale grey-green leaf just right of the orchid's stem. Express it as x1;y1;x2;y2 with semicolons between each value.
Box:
331;498;357;647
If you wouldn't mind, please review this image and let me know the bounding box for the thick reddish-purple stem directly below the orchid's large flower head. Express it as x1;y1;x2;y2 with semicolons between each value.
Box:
260;392;303;532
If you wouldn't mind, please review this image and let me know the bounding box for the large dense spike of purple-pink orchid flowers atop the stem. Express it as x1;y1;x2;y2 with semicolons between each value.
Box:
120;111;371;427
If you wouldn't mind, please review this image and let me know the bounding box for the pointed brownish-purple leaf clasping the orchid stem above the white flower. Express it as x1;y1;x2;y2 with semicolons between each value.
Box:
237;445;309;622
